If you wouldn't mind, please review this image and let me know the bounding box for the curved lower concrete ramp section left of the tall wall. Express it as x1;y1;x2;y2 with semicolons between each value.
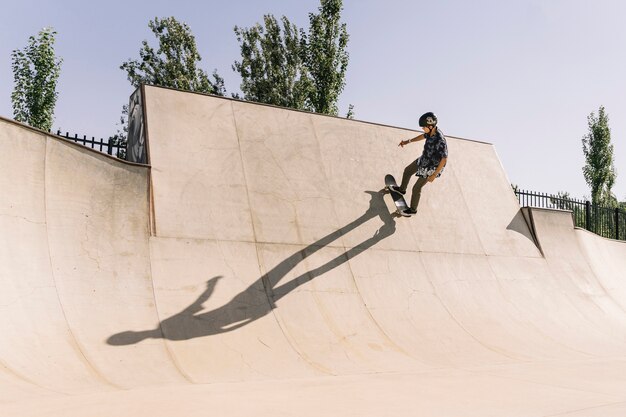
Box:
0;119;182;394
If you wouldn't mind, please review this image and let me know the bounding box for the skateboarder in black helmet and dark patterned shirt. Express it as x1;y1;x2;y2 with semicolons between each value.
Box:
391;112;448;216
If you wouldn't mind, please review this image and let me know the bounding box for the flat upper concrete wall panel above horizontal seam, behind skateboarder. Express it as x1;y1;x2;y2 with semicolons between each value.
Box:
146;87;537;256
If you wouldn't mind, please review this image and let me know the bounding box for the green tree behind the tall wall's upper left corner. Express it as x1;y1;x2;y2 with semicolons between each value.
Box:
120;17;225;96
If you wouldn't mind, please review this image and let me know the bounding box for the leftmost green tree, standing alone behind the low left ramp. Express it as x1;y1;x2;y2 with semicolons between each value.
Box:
11;28;63;130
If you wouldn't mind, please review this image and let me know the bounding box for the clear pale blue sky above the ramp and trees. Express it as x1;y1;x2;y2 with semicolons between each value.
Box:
0;0;626;201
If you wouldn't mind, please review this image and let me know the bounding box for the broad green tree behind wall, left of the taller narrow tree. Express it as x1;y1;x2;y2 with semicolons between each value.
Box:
232;15;311;110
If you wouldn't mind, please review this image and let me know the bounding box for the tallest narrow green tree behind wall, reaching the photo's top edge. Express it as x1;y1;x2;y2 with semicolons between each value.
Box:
301;0;349;115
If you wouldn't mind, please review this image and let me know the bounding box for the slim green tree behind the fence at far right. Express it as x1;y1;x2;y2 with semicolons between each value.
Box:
582;106;617;207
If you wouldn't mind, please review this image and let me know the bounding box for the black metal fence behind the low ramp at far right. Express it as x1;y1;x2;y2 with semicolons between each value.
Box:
514;190;626;240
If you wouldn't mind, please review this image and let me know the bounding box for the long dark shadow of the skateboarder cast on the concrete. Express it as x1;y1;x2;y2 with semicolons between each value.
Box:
107;190;396;346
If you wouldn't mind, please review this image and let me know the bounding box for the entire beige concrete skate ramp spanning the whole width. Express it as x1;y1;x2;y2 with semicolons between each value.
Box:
0;87;626;416
